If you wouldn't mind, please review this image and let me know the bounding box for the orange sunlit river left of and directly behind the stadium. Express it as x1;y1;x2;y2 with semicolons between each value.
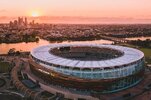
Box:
0;39;113;54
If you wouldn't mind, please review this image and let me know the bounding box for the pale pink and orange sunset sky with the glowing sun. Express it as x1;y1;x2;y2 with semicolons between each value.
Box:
0;0;151;23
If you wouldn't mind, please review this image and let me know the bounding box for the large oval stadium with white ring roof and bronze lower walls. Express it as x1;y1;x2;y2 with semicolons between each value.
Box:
29;44;144;94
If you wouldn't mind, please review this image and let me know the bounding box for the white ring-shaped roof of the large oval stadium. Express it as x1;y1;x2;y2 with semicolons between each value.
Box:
31;44;144;68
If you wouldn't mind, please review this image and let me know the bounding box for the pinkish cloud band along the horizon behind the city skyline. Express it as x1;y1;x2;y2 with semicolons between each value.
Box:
0;16;151;24
